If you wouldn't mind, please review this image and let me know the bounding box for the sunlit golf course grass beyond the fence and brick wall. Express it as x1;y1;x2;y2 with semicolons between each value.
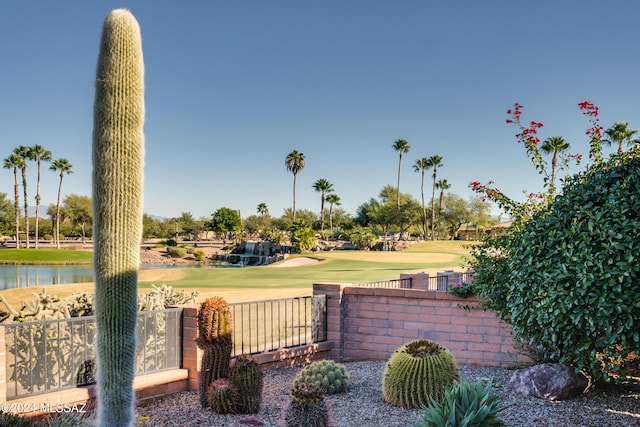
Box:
0;241;476;306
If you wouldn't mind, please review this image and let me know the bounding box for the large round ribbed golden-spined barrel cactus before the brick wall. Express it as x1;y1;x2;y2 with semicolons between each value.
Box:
382;339;460;408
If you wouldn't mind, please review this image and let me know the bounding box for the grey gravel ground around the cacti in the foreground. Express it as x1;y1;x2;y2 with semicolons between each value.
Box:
137;361;640;427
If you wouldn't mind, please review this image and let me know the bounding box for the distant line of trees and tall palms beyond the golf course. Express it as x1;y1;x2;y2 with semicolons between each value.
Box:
0;139;495;249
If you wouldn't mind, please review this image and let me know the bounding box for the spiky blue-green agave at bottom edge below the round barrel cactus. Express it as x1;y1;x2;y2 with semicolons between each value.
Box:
418;381;504;427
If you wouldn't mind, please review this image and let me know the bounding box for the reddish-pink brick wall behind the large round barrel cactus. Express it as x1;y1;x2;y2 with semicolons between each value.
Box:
313;277;530;366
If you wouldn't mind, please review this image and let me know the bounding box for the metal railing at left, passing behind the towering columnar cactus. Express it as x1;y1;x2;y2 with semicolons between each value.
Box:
4;308;182;399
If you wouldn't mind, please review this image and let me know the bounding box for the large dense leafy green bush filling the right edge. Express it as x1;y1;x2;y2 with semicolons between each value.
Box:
474;149;640;380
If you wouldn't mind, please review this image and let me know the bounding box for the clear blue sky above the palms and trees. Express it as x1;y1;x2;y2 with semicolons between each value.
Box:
0;0;640;221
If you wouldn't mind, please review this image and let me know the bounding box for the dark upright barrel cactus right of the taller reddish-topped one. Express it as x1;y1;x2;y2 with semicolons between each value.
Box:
229;355;262;414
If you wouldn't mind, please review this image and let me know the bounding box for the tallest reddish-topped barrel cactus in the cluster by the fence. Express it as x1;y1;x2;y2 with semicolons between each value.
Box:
196;297;233;408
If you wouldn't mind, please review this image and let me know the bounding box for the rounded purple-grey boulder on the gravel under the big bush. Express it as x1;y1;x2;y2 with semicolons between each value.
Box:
508;363;591;400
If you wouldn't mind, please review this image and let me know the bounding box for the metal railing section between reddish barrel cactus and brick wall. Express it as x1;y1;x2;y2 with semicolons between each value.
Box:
229;295;327;356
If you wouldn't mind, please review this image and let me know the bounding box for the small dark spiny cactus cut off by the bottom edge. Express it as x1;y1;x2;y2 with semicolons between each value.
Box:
282;382;331;427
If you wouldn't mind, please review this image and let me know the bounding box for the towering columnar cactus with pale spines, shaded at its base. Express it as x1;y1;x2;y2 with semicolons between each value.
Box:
93;9;144;427
